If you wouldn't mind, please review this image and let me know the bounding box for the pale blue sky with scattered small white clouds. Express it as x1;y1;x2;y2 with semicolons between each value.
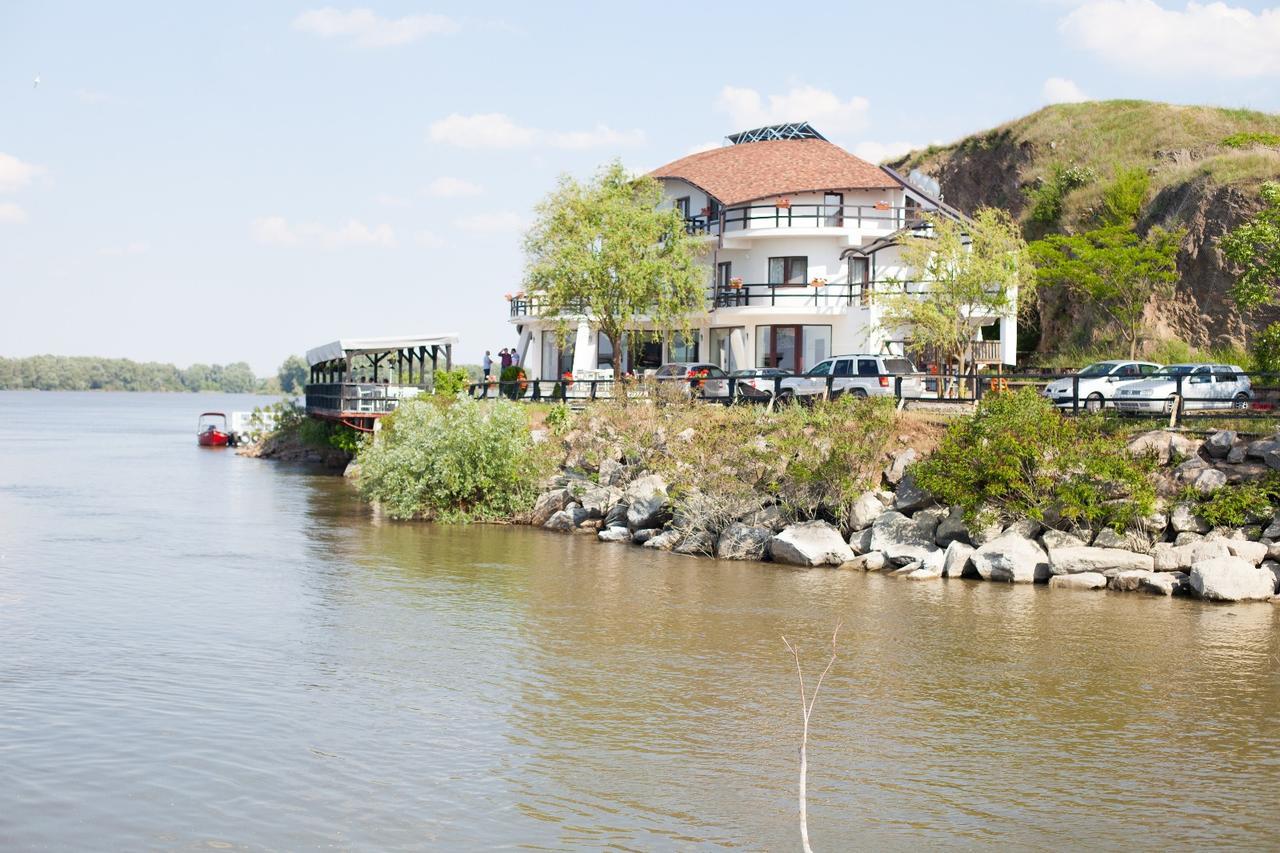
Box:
0;0;1280;373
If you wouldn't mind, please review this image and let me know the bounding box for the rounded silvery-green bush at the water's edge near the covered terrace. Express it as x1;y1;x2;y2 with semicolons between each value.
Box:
358;398;547;521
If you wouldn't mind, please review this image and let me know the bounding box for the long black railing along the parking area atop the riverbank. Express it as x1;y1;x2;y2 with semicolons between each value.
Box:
468;366;1280;425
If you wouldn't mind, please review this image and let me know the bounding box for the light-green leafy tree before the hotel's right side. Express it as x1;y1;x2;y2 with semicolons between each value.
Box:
884;207;1036;389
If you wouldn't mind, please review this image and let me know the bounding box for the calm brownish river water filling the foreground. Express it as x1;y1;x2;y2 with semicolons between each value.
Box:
0;392;1280;850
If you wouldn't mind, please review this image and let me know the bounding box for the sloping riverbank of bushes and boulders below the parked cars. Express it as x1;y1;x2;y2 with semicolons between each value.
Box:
317;391;1280;601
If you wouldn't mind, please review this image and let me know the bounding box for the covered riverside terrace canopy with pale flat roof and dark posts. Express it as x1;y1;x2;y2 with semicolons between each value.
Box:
307;334;458;386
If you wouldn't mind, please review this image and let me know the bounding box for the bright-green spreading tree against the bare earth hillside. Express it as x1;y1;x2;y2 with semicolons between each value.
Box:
1030;225;1184;359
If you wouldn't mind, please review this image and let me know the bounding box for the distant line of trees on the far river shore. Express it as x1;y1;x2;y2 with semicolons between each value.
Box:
0;356;282;393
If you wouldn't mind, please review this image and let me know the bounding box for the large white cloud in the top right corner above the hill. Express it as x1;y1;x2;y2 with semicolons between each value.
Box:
1059;0;1280;78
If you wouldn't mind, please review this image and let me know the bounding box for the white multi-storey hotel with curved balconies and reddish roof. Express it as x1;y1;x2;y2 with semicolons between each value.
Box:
511;123;1018;379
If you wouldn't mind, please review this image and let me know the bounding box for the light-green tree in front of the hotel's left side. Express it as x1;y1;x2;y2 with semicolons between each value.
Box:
525;160;709;378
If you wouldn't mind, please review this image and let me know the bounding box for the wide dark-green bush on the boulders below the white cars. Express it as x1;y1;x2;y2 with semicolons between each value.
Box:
911;388;1156;530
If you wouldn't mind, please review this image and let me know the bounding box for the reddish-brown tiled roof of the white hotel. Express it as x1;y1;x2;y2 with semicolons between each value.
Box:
649;140;897;205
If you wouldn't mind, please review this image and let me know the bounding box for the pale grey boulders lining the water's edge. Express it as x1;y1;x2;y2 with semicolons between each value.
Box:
527;430;1280;602
